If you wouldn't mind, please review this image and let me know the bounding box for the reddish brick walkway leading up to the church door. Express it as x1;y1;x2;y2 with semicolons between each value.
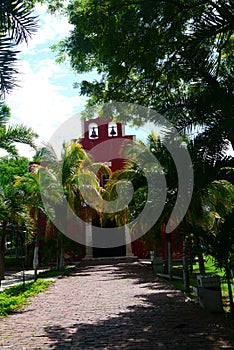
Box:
0;260;234;350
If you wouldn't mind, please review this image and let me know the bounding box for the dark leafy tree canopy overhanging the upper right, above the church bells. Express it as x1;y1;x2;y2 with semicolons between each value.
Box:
52;0;234;150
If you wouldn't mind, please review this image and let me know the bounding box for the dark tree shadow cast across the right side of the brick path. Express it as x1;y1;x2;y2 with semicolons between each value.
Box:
45;260;234;350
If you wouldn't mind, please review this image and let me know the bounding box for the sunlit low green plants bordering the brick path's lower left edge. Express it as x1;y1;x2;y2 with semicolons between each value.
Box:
0;279;52;316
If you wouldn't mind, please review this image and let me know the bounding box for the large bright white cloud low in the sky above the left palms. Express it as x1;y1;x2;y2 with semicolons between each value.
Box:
7;59;85;141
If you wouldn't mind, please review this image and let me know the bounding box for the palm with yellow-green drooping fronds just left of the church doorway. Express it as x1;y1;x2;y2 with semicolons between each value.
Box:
37;142;105;268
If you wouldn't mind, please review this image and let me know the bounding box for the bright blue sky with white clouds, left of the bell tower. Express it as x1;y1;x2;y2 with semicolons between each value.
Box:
6;5;95;157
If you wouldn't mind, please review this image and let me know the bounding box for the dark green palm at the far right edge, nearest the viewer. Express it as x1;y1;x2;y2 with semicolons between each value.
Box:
187;180;234;317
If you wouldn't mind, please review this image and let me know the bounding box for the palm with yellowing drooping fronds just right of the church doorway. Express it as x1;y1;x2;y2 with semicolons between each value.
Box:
102;133;174;278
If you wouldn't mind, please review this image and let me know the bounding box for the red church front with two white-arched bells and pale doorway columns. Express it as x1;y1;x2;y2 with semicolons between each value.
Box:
79;118;135;258
